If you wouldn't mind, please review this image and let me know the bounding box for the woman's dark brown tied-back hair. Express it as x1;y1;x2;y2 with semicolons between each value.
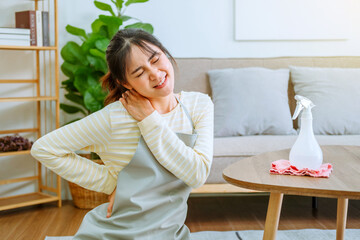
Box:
101;28;176;105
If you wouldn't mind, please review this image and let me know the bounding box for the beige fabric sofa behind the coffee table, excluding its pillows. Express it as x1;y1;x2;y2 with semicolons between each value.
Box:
175;57;360;194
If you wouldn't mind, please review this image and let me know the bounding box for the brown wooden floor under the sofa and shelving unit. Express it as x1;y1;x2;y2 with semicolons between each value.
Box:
0;196;360;240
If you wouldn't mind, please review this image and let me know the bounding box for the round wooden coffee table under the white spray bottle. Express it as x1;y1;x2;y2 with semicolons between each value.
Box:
223;146;360;239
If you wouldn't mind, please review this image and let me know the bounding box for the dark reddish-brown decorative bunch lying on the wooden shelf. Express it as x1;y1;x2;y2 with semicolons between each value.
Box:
0;134;33;152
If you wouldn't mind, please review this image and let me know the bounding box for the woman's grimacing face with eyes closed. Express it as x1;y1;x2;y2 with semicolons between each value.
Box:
124;43;174;99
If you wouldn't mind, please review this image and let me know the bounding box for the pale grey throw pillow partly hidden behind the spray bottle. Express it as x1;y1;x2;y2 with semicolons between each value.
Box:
290;66;360;135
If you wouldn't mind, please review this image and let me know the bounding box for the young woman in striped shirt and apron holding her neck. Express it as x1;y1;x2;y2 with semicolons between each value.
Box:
31;29;213;240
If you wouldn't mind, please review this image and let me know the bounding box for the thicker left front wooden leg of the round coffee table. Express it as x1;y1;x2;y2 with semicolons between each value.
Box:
263;192;284;240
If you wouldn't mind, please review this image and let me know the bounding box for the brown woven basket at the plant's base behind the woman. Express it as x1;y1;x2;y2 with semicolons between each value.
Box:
68;160;109;209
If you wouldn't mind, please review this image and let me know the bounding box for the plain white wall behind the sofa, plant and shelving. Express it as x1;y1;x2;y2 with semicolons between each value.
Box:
0;0;360;199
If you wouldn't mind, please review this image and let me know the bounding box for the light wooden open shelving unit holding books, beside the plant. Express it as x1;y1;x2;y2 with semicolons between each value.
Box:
0;0;61;211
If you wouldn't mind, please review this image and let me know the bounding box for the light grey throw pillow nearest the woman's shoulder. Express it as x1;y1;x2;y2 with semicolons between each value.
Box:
208;67;296;137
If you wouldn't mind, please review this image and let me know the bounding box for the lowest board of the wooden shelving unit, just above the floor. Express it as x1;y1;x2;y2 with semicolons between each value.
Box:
0;192;59;211
